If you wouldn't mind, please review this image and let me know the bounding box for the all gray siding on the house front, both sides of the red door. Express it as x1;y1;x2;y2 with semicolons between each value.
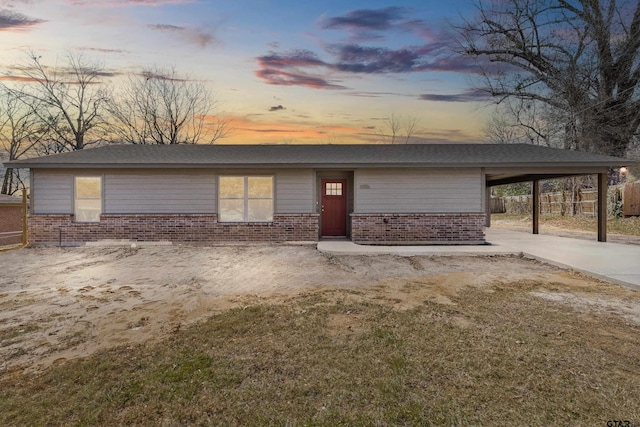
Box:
32;168;484;214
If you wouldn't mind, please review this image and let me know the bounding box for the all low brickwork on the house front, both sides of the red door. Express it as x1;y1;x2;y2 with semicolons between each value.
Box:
28;214;485;246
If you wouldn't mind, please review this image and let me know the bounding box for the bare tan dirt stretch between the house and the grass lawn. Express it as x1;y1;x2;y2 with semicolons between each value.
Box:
0;245;640;378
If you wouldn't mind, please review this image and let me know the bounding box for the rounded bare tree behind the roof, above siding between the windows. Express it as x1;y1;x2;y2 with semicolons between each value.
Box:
110;68;230;144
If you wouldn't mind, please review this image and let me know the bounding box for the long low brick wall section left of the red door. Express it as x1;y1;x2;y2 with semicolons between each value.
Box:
28;214;318;246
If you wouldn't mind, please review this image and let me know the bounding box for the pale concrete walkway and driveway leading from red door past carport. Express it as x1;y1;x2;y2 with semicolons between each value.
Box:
318;228;640;290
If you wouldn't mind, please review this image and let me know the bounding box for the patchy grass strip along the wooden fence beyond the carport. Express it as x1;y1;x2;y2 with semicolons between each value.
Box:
491;214;640;237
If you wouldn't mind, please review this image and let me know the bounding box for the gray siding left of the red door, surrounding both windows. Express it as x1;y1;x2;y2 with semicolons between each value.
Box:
33;169;314;214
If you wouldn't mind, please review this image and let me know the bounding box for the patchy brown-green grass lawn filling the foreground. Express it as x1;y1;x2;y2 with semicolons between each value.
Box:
0;276;640;426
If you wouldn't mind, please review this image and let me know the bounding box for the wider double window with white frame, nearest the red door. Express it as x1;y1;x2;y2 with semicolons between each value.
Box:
218;176;273;222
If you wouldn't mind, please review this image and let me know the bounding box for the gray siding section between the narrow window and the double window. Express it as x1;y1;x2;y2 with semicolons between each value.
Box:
104;170;217;214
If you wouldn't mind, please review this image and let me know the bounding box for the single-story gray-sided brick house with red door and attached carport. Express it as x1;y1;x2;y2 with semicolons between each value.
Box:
3;144;625;245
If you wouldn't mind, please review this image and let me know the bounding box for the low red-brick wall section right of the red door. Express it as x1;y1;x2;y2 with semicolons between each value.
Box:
351;214;485;244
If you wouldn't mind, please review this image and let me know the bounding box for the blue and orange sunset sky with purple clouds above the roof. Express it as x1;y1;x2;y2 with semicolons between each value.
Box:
0;0;489;143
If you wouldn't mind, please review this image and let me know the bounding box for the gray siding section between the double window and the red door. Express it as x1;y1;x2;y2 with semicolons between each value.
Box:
275;169;314;214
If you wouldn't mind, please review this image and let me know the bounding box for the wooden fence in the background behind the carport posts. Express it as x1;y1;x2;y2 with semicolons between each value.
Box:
491;182;640;217
